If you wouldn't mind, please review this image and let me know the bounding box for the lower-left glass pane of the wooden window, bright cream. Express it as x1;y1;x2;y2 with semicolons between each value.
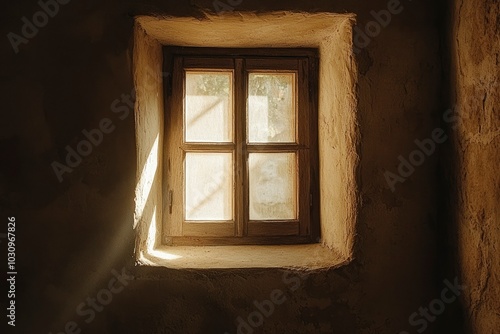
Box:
184;153;233;220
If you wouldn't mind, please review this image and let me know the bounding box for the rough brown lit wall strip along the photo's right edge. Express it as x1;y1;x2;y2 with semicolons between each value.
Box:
442;0;500;334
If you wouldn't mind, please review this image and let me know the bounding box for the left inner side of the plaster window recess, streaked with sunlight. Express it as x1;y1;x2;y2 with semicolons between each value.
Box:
133;26;164;256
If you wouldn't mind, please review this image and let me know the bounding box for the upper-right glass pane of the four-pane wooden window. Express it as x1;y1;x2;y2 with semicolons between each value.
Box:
248;73;296;143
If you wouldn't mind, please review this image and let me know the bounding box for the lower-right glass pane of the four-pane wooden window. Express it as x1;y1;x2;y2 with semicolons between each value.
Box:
248;153;297;220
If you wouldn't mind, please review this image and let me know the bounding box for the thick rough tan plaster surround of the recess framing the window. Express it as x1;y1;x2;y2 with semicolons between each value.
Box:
134;12;359;269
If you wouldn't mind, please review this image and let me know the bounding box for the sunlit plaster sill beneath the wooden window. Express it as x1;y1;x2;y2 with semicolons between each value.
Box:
137;244;346;270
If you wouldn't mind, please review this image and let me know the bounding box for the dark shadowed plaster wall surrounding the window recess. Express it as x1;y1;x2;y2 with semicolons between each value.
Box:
0;0;441;334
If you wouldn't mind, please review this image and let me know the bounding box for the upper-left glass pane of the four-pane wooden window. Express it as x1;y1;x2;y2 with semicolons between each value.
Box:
184;71;233;142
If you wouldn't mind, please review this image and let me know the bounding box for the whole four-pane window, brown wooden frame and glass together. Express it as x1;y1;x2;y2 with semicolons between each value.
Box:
163;47;319;245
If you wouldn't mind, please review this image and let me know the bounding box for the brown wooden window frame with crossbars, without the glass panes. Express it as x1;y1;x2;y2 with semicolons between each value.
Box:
162;47;320;246
